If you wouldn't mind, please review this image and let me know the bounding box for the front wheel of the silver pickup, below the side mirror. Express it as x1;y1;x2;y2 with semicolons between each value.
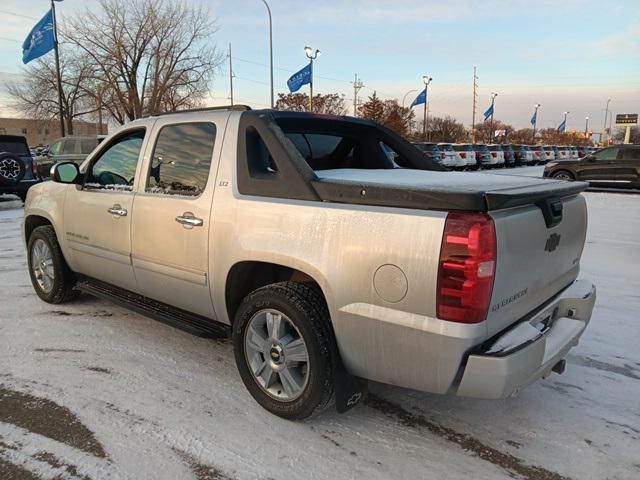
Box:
27;225;79;304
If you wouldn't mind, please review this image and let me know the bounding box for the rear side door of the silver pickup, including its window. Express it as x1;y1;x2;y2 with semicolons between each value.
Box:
132;119;223;318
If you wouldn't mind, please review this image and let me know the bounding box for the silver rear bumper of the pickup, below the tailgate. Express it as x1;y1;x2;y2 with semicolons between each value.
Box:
456;280;596;399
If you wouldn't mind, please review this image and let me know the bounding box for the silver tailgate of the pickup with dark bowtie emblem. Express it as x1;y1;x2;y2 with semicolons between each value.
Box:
487;195;587;336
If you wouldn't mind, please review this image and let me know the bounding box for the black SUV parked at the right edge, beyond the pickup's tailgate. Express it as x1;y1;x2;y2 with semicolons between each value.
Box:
544;145;640;188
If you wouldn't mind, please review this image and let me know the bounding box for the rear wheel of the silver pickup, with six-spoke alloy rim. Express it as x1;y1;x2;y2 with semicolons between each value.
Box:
233;282;336;420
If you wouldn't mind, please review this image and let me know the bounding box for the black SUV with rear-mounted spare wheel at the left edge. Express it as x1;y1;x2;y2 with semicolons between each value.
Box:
0;135;40;202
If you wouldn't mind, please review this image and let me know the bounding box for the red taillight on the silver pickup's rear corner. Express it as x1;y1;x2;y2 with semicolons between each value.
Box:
436;213;496;323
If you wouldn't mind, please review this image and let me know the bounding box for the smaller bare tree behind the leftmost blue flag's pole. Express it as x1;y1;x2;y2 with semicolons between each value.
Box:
7;48;96;135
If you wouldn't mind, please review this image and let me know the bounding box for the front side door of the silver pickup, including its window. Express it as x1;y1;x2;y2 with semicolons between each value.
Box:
64;128;145;292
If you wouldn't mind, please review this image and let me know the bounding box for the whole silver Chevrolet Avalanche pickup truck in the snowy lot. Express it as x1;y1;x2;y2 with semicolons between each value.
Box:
24;106;595;419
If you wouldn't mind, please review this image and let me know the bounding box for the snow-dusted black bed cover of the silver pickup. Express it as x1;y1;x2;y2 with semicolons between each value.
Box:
312;170;588;212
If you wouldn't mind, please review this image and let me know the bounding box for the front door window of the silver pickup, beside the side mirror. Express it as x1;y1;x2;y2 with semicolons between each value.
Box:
84;130;144;191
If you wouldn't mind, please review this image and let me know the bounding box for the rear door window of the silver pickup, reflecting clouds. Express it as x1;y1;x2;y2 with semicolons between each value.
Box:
146;123;216;196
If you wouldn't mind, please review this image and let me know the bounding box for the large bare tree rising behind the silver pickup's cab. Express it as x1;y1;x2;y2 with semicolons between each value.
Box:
64;0;222;123
